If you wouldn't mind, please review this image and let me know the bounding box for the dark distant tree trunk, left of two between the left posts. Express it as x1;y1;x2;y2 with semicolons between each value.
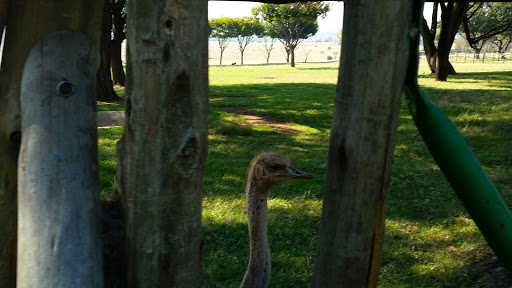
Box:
96;0;120;101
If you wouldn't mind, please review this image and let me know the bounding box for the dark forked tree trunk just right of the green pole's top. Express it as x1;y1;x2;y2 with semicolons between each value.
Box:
420;1;469;81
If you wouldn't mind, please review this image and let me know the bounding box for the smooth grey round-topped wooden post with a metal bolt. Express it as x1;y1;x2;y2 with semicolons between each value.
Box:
17;31;103;288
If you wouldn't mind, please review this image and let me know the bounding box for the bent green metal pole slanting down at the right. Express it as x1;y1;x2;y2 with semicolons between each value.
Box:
404;0;512;271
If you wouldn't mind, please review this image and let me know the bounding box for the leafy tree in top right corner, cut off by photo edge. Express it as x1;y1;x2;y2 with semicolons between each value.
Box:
461;2;512;58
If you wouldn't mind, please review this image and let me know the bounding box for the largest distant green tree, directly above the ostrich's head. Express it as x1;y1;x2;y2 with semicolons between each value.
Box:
252;2;330;67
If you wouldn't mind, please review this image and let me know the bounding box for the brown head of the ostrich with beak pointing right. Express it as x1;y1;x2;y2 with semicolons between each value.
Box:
247;152;313;188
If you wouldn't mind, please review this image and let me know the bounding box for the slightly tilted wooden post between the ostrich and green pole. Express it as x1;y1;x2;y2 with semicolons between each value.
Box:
311;0;419;288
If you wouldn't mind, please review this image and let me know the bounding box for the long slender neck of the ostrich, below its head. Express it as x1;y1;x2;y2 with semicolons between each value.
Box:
240;177;270;288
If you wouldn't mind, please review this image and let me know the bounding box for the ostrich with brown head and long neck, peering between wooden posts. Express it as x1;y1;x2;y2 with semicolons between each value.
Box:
240;152;313;288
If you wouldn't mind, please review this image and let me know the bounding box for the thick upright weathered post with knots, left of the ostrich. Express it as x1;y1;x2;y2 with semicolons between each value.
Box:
118;0;208;288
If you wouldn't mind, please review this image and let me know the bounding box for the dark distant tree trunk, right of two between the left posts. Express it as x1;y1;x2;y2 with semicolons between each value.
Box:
110;0;126;86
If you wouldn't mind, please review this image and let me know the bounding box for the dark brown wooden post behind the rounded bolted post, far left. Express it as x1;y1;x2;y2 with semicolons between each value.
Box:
0;0;103;288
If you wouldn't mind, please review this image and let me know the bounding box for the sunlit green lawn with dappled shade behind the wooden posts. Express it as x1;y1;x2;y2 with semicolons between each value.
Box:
99;61;512;287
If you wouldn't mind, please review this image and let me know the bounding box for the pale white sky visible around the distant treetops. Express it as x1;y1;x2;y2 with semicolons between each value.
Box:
208;1;432;33
